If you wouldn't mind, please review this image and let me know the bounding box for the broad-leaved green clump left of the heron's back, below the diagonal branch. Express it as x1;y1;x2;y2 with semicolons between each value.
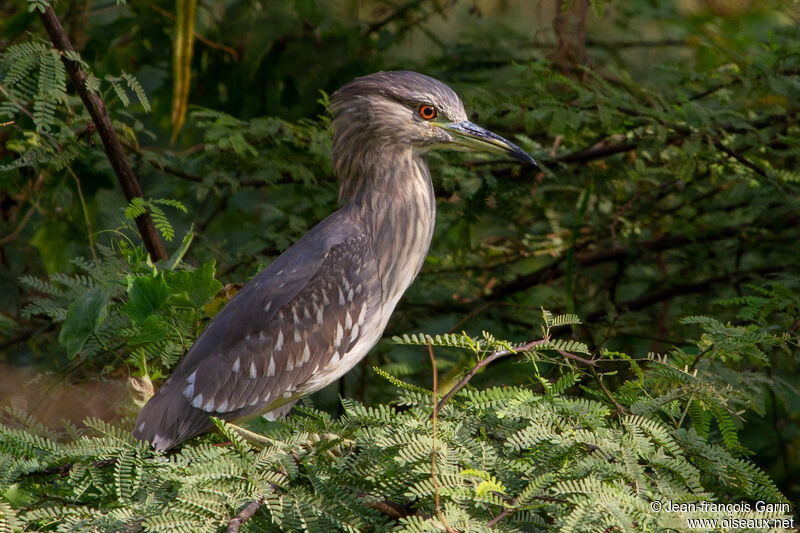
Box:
21;240;222;378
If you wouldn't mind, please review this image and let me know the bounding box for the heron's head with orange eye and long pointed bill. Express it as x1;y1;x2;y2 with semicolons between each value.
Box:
331;71;536;172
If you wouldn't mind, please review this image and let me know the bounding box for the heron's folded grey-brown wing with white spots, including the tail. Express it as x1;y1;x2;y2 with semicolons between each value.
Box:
134;211;382;449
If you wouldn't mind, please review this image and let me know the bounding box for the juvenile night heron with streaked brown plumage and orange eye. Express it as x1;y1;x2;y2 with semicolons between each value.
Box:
134;68;534;450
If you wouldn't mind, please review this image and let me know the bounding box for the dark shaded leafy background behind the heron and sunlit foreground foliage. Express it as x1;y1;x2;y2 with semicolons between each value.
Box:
0;0;800;529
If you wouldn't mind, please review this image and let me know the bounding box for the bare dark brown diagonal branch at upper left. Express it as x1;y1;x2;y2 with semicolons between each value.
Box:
39;5;167;261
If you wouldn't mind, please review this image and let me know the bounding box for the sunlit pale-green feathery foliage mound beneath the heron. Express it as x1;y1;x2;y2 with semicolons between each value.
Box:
0;338;783;531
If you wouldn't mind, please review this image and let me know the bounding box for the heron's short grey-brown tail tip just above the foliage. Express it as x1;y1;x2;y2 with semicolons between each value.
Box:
133;387;214;451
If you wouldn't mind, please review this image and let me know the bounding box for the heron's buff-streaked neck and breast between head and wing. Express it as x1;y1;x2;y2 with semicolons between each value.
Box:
339;145;436;312
